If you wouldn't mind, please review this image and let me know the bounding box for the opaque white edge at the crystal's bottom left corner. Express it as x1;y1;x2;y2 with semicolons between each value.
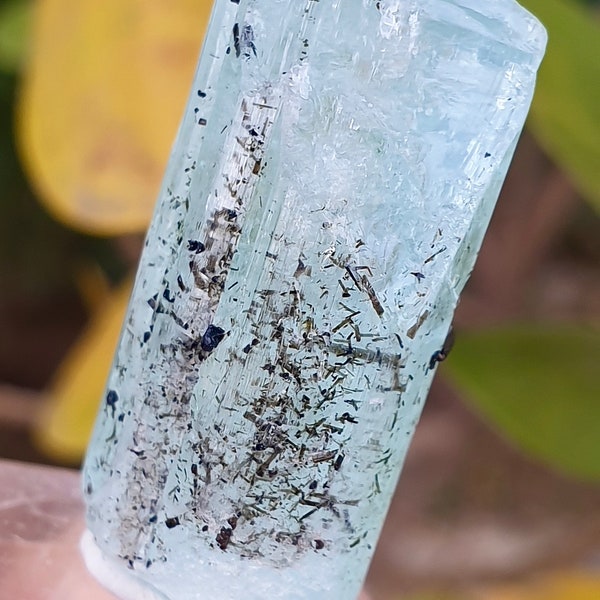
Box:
79;529;168;600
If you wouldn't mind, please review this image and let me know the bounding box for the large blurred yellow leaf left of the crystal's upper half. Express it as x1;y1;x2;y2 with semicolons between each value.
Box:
18;0;212;235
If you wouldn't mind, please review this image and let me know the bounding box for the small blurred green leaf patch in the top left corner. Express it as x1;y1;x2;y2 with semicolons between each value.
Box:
0;0;31;73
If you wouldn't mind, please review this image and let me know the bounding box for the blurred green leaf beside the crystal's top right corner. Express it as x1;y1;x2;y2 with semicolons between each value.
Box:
521;0;600;210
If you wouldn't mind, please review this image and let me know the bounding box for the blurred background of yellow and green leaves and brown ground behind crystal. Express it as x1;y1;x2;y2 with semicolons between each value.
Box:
0;0;600;600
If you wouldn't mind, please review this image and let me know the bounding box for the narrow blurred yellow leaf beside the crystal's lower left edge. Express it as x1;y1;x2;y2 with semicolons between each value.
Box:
34;281;132;464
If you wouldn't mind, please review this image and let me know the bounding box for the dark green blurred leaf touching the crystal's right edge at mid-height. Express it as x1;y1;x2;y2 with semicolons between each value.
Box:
445;326;600;480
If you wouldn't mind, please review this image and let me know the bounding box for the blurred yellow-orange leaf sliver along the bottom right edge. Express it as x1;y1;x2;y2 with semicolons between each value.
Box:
475;571;600;600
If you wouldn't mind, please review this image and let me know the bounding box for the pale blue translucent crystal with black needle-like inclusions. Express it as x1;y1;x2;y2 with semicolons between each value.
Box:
83;0;545;600
